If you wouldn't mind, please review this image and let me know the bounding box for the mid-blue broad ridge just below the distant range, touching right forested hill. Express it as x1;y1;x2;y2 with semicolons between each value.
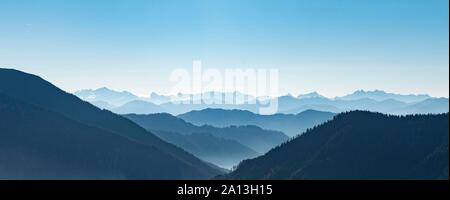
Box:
178;109;335;137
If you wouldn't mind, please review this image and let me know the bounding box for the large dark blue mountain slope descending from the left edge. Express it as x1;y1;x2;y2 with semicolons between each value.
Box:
0;69;223;179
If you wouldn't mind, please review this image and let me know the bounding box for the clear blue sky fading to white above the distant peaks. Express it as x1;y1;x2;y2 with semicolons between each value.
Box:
0;0;449;97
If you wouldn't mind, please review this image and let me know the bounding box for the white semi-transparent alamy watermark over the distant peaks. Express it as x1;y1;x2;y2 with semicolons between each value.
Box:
170;61;279;114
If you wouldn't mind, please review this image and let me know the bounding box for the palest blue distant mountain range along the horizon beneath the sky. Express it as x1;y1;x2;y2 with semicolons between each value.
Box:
74;88;449;115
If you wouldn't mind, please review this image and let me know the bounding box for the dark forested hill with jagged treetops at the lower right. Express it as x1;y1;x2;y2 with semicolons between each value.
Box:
223;111;449;180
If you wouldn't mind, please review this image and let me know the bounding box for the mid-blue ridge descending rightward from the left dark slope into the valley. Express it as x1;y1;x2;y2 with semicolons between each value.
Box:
125;113;289;153
